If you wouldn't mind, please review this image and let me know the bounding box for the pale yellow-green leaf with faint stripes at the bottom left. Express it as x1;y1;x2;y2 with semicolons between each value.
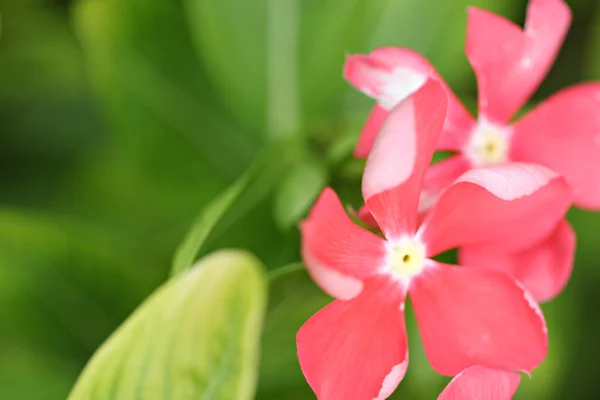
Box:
69;250;266;400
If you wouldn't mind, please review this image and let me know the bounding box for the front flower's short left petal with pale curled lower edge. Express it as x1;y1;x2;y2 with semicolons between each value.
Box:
300;188;386;300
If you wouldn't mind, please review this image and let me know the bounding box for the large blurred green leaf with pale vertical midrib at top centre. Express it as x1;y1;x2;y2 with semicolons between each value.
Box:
185;0;385;137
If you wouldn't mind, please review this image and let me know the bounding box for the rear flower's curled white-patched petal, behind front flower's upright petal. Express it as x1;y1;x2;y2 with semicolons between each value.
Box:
344;47;474;158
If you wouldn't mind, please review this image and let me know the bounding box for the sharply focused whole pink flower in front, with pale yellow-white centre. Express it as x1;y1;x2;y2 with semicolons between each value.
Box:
297;81;572;400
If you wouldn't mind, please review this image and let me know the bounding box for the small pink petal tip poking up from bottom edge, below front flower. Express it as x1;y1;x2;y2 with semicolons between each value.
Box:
438;366;521;400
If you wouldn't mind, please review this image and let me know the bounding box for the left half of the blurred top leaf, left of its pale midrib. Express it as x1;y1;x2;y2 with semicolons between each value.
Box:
184;0;267;134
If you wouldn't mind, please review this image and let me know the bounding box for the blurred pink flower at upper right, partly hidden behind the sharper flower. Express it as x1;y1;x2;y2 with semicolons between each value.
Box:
344;0;588;301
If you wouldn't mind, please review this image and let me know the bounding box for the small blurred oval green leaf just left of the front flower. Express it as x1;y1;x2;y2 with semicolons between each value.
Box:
274;160;327;229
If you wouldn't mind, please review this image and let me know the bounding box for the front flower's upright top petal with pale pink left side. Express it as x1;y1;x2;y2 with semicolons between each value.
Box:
362;80;446;239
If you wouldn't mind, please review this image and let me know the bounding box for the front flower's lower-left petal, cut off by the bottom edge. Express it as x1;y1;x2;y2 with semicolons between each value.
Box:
296;278;408;400
